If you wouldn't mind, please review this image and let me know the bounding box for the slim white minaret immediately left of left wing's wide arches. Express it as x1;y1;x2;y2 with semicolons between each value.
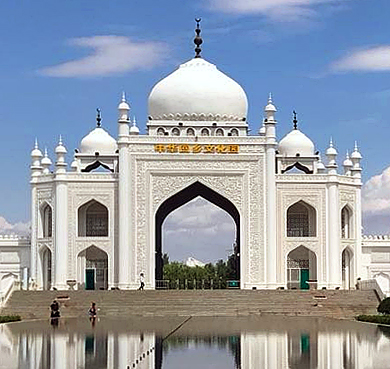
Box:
53;136;68;290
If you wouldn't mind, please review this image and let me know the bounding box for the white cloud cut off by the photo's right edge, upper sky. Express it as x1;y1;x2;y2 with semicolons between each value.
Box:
331;45;390;72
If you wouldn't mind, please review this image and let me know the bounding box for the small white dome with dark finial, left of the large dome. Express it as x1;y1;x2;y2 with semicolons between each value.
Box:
80;127;117;155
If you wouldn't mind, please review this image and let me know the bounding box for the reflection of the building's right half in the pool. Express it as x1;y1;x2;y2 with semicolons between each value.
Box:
241;327;390;369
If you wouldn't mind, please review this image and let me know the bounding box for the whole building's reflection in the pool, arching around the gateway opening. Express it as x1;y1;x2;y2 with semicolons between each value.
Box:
0;321;390;369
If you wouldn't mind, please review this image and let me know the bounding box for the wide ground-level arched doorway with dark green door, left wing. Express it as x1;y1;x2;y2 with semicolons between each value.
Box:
78;246;108;290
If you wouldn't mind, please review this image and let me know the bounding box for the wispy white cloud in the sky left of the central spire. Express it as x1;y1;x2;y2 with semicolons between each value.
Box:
39;36;168;77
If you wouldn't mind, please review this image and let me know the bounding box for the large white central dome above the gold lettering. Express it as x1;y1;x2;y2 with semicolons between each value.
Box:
149;58;248;122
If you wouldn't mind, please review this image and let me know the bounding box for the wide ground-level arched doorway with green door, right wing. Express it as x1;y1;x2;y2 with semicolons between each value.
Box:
287;246;317;290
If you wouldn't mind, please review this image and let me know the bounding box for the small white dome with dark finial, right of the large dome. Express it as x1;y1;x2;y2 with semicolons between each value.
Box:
279;129;314;157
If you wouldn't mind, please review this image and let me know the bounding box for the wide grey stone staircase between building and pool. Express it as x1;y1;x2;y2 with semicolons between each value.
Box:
0;290;379;319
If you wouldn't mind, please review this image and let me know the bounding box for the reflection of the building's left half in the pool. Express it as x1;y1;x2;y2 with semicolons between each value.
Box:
0;327;155;369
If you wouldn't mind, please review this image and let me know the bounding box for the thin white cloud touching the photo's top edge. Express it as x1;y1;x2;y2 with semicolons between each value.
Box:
208;0;348;21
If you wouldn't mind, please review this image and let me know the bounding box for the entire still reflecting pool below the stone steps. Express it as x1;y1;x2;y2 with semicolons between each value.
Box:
0;316;390;369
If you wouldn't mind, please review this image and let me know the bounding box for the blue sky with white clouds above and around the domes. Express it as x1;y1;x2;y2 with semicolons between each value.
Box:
0;0;390;256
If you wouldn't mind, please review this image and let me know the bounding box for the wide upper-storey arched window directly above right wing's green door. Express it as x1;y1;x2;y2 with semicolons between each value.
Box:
287;201;316;237
